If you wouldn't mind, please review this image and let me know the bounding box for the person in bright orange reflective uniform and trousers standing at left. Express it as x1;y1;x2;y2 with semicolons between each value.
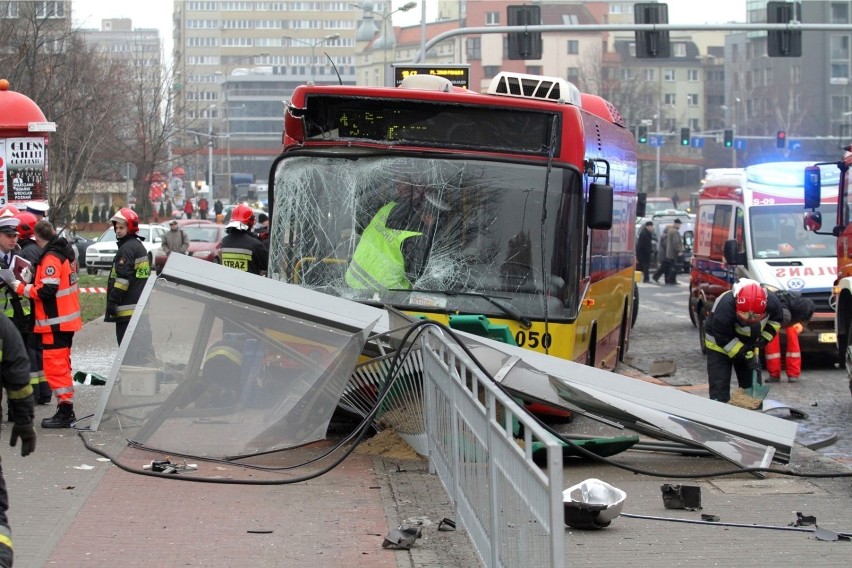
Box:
3;221;83;428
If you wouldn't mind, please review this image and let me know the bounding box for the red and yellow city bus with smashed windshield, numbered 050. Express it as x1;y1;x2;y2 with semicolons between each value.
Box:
269;73;637;369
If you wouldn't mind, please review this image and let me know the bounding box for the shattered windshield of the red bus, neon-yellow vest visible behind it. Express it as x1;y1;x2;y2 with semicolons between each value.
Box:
269;153;584;321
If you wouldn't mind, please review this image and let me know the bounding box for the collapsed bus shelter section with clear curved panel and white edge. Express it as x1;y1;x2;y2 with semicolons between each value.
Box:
92;255;382;459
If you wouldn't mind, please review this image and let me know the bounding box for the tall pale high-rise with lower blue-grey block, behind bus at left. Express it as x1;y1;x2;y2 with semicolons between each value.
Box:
173;0;362;189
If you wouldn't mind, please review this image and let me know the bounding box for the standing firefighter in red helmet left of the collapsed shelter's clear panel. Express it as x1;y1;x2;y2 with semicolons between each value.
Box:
104;207;151;345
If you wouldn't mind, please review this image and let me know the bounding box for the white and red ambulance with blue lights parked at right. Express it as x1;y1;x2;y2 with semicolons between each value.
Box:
689;162;839;353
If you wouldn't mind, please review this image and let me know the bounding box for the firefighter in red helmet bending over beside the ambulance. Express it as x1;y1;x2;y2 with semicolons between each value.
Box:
704;278;783;402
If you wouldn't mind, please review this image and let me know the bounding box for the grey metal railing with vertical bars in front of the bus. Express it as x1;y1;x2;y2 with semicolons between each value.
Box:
421;326;565;568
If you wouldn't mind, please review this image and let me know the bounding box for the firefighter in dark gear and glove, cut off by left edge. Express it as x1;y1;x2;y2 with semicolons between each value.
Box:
0;314;36;568
